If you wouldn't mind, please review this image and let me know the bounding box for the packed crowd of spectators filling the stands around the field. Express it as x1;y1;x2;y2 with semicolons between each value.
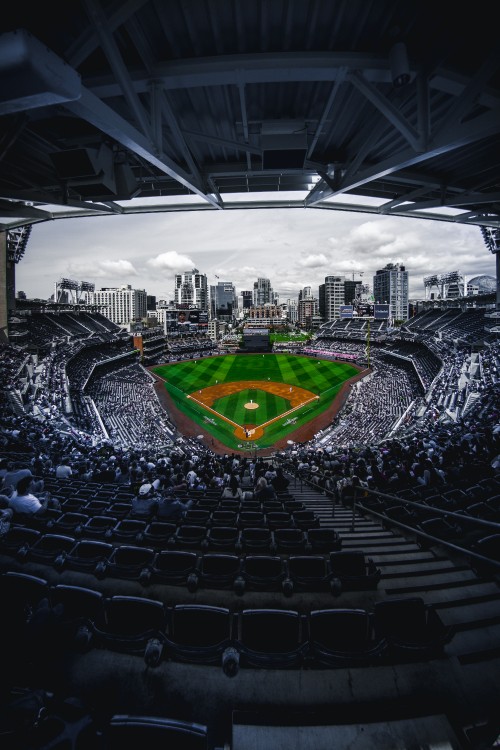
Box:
0;306;500;528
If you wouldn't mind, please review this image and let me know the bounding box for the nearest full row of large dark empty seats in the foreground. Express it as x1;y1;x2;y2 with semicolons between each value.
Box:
0;572;454;677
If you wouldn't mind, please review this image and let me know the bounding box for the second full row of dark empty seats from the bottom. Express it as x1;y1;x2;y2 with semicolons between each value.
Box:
10;534;381;596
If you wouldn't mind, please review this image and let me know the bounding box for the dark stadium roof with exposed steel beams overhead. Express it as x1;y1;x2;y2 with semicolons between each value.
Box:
0;0;500;235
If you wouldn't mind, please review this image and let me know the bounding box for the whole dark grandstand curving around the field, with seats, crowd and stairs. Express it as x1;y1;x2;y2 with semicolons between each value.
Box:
0;311;500;750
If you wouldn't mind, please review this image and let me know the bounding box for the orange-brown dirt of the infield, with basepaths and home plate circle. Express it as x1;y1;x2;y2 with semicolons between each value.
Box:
188;380;319;440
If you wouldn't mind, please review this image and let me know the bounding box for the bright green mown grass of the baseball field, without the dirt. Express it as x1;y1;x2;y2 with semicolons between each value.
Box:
153;354;358;450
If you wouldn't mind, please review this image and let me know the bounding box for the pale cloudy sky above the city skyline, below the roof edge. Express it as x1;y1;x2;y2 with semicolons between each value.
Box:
16;198;495;302
